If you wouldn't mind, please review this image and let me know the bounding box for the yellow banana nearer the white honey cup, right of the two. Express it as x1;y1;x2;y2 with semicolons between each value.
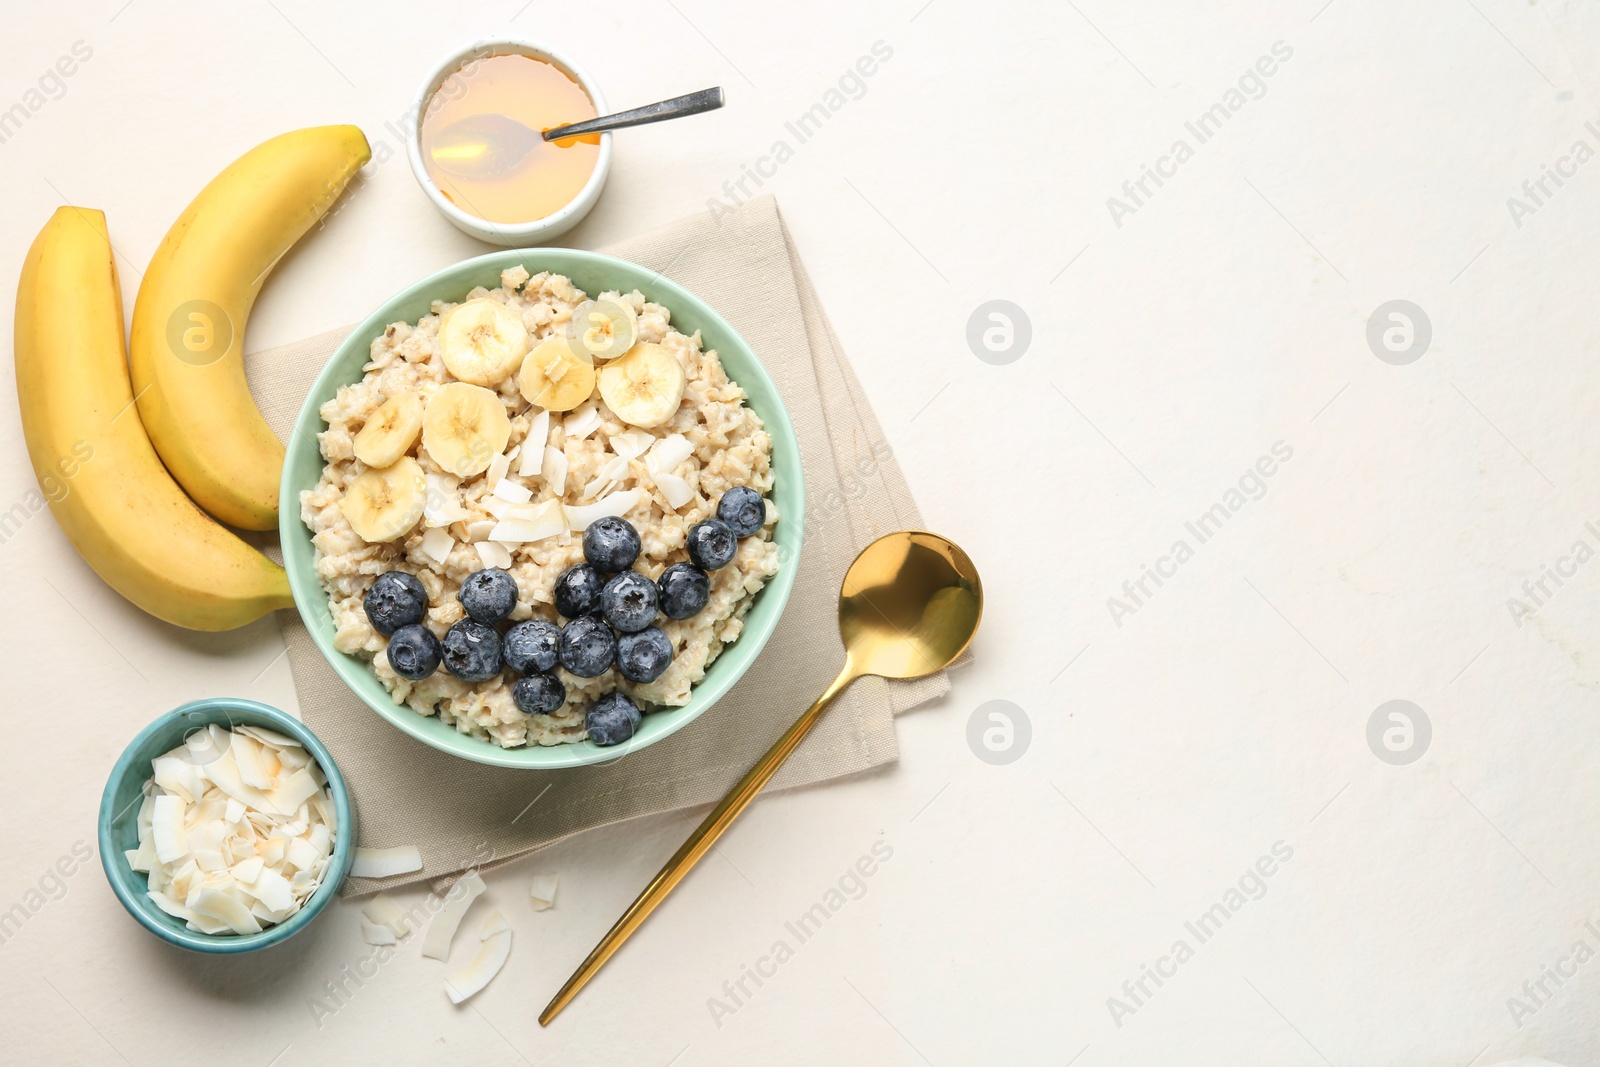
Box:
130;126;371;530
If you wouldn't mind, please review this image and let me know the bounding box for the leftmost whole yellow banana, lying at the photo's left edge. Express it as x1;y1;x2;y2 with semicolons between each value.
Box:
14;208;294;630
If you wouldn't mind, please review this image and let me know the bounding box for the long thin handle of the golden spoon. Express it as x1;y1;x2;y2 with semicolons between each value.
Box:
539;661;856;1025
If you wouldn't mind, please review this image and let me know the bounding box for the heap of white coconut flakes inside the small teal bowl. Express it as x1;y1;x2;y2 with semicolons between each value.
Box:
125;725;334;934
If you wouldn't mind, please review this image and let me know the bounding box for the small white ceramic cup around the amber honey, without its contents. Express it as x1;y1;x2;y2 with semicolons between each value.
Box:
406;37;611;248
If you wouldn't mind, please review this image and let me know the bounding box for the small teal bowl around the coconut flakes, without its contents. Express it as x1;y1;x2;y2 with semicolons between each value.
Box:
99;697;355;955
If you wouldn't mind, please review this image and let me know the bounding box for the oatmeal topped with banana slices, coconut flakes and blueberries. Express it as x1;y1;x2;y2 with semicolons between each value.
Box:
301;267;779;749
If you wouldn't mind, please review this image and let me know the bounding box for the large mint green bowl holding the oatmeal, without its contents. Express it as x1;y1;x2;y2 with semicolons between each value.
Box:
278;248;805;771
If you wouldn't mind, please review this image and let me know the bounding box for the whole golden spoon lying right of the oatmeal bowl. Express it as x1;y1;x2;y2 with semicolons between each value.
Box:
539;530;984;1025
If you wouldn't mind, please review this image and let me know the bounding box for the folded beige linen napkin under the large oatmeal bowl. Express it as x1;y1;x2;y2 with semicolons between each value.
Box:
246;197;949;894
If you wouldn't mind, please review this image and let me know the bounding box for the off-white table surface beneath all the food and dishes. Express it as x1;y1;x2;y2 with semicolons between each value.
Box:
0;0;1600;1067
